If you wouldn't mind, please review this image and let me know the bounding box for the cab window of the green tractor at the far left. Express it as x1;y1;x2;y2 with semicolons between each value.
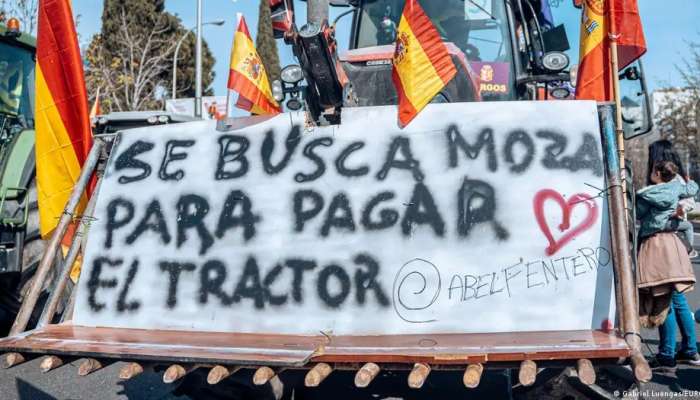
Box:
0;42;34;126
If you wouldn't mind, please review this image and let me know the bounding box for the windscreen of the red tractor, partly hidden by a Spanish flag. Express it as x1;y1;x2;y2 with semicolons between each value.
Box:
355;0;515;101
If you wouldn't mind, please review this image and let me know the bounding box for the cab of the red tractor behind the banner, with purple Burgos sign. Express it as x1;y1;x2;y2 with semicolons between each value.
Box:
273;0;651;138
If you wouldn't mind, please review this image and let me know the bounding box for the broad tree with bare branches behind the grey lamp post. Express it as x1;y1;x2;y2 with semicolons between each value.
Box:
86;0;214;111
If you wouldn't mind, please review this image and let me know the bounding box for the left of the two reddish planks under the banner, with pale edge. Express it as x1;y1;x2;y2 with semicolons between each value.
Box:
0;324;326;366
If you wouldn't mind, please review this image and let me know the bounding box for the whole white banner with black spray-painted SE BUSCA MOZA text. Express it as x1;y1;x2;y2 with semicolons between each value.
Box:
74;101;614;334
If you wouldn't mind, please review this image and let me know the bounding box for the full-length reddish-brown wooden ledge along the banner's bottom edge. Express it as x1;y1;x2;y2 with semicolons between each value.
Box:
0;324;630;367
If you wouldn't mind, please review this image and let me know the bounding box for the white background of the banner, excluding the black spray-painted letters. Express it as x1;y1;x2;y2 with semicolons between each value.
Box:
74;101;614;334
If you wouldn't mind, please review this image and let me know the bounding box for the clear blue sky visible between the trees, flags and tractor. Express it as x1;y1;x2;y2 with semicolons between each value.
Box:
73;0;700;95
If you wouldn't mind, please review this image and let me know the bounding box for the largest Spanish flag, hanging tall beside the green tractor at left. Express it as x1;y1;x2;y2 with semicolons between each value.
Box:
35;0;92;237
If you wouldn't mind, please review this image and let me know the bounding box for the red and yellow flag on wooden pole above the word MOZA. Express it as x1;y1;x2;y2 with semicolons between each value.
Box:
576;0;646;101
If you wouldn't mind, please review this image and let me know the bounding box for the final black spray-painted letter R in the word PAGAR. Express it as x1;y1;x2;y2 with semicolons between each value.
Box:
457;177;510;240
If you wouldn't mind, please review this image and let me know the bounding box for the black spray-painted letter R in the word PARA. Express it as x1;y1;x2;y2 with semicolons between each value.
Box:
177;194;214;254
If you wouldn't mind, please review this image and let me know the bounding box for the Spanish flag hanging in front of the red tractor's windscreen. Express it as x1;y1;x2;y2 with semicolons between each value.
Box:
392;0;457;127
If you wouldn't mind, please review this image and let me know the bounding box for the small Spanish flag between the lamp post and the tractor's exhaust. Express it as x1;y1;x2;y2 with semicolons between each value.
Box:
228;14;280;115
